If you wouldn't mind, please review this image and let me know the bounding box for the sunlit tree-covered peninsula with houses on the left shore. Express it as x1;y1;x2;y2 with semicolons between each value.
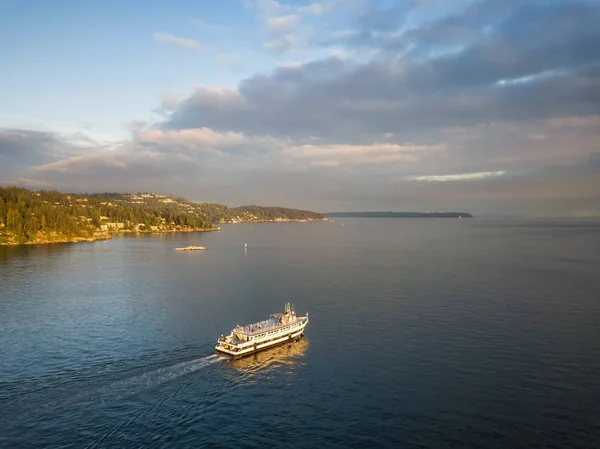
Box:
0;187;325;245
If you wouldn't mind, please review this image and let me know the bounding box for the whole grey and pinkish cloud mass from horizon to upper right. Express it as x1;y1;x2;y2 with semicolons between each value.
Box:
0;0;600;214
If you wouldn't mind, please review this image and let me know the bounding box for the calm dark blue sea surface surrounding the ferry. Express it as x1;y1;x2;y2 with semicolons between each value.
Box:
0;218;600;448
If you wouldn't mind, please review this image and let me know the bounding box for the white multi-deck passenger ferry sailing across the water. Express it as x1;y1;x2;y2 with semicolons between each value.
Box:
215;303;308;359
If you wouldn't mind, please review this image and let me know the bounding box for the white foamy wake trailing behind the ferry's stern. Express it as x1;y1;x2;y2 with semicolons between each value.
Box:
93;354;227;403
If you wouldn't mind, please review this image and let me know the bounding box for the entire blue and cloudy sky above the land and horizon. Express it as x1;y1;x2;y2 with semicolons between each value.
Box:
0;0;600;216
